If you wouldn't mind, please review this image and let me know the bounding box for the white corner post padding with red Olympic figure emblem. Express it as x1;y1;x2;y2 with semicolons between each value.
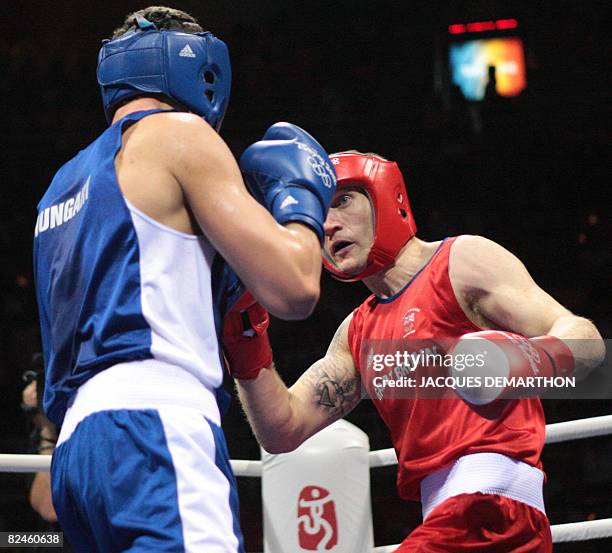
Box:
261;420;374;553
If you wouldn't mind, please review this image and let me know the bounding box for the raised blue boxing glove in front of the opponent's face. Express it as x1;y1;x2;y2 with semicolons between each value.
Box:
240;123;336;241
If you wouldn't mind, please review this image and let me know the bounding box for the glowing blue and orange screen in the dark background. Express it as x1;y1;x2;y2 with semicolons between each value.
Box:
450;37;527;100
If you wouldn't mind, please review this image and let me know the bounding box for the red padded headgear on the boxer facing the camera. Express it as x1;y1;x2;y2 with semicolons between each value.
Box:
323;152;416;282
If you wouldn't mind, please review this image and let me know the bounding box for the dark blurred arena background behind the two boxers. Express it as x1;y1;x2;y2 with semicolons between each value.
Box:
0;0;612;553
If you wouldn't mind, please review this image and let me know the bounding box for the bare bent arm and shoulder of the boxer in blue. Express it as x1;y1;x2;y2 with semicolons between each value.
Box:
116;113;321;319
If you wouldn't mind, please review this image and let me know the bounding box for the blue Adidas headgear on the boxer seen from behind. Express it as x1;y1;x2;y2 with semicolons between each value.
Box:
97;17;232;131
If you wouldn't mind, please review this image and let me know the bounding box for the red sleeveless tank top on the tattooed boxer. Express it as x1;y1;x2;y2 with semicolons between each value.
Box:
348;238;545;500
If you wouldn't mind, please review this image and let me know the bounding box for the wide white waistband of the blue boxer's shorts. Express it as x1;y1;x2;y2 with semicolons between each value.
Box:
57;359;221;445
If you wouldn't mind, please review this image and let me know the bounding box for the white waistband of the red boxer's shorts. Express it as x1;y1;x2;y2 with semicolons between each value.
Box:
421;453;546;520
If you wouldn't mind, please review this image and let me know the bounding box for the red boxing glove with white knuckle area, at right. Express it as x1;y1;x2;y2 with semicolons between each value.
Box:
449;330;574;405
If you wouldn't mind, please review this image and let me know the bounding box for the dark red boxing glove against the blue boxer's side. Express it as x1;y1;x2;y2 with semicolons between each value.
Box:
223;290;272;380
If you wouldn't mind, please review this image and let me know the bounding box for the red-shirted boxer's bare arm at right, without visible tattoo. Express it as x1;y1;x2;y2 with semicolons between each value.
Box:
450;236;605;377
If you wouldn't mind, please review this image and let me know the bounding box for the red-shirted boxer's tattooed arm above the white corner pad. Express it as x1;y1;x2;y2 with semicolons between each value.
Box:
236;316;361;453
